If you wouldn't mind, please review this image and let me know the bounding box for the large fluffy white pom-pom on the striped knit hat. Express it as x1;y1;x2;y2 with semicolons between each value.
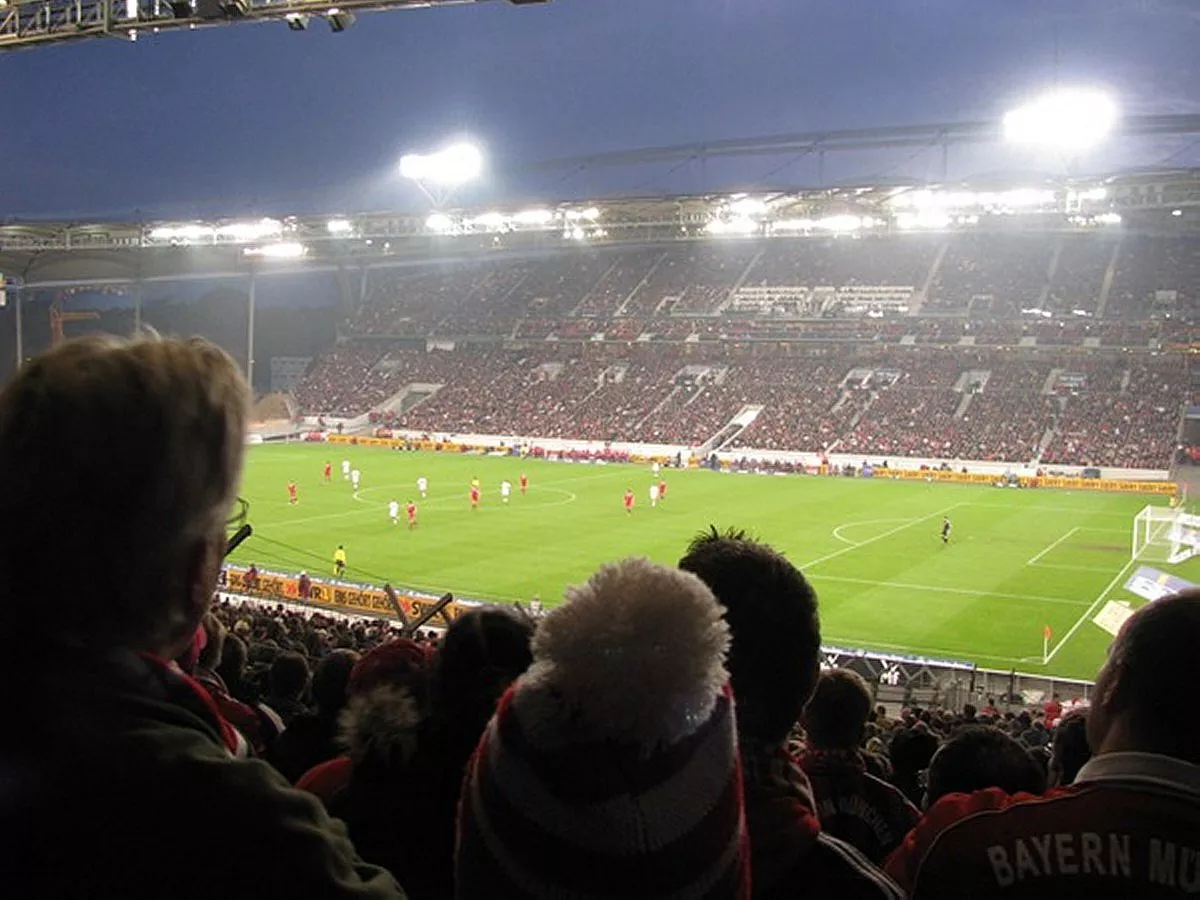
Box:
521;559;730;750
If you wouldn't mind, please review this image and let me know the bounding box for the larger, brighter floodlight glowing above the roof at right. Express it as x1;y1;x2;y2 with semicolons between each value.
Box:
1004;88;1117;151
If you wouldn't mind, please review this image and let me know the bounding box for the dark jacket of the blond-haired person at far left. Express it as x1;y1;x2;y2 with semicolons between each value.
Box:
0;654;403;900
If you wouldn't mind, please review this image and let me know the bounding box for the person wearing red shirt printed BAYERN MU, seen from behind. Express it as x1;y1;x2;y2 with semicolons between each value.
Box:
888;592;1200;900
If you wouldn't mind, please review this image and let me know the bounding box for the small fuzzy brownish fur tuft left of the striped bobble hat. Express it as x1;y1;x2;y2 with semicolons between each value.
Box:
337;684;424;764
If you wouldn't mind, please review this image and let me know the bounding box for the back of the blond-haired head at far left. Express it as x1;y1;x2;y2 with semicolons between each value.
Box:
0;334;248;649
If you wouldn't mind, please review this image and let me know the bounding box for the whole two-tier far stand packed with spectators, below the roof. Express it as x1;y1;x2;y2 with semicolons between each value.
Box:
285;233;1200;468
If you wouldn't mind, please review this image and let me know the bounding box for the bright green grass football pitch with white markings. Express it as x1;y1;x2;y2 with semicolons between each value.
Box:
234;444;1200;678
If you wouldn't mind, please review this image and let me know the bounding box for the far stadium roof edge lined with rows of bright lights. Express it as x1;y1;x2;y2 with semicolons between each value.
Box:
0;162;1200;287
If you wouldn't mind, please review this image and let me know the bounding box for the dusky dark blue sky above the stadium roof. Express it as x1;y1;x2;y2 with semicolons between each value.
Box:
0;0;1200;218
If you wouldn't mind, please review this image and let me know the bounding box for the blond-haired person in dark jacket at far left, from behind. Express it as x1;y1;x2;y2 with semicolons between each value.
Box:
0;337;402;900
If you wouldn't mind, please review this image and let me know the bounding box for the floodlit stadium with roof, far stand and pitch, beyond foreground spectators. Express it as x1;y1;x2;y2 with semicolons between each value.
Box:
9;153;1200;689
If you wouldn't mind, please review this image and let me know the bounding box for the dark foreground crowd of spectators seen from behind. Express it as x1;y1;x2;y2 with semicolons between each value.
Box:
0;337;1200;900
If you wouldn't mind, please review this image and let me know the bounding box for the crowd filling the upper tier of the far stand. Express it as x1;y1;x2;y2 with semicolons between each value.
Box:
331;233;1200;343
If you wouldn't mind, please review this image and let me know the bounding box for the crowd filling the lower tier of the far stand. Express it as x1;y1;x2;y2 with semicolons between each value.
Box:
296;342;1189;468
